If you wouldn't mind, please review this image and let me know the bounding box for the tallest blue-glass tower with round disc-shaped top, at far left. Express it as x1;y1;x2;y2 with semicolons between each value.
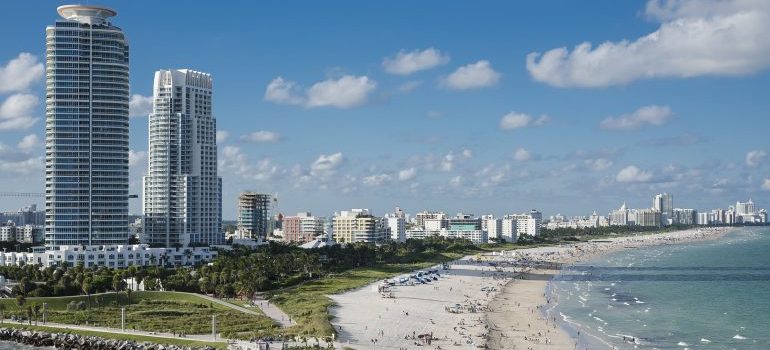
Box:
45;5;128;249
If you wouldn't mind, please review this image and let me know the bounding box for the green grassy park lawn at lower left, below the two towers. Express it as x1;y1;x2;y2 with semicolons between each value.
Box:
0;292;279;338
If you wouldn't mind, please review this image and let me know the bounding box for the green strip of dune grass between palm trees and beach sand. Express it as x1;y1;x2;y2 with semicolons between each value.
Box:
270;252;462;337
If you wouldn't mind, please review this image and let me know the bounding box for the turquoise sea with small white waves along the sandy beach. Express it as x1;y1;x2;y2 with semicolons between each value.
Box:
547;227;770;349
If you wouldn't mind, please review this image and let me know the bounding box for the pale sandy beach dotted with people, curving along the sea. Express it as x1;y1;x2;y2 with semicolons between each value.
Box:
331;228;727;349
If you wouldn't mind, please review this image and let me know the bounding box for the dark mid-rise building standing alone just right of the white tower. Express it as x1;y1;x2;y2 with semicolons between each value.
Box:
237;192;272;240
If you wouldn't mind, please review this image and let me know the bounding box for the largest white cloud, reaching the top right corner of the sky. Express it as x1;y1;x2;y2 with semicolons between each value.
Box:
527;0;770;87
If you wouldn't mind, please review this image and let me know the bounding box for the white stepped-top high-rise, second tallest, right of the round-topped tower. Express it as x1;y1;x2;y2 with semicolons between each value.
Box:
142;69;224;247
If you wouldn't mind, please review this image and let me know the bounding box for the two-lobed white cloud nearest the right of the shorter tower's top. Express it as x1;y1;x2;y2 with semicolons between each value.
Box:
264;75;377;108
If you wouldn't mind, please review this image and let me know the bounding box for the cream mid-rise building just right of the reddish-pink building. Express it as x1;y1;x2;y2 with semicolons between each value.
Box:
332;209;388;244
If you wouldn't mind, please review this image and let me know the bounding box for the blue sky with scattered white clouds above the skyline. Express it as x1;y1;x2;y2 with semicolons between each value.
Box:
0;0;770;219
